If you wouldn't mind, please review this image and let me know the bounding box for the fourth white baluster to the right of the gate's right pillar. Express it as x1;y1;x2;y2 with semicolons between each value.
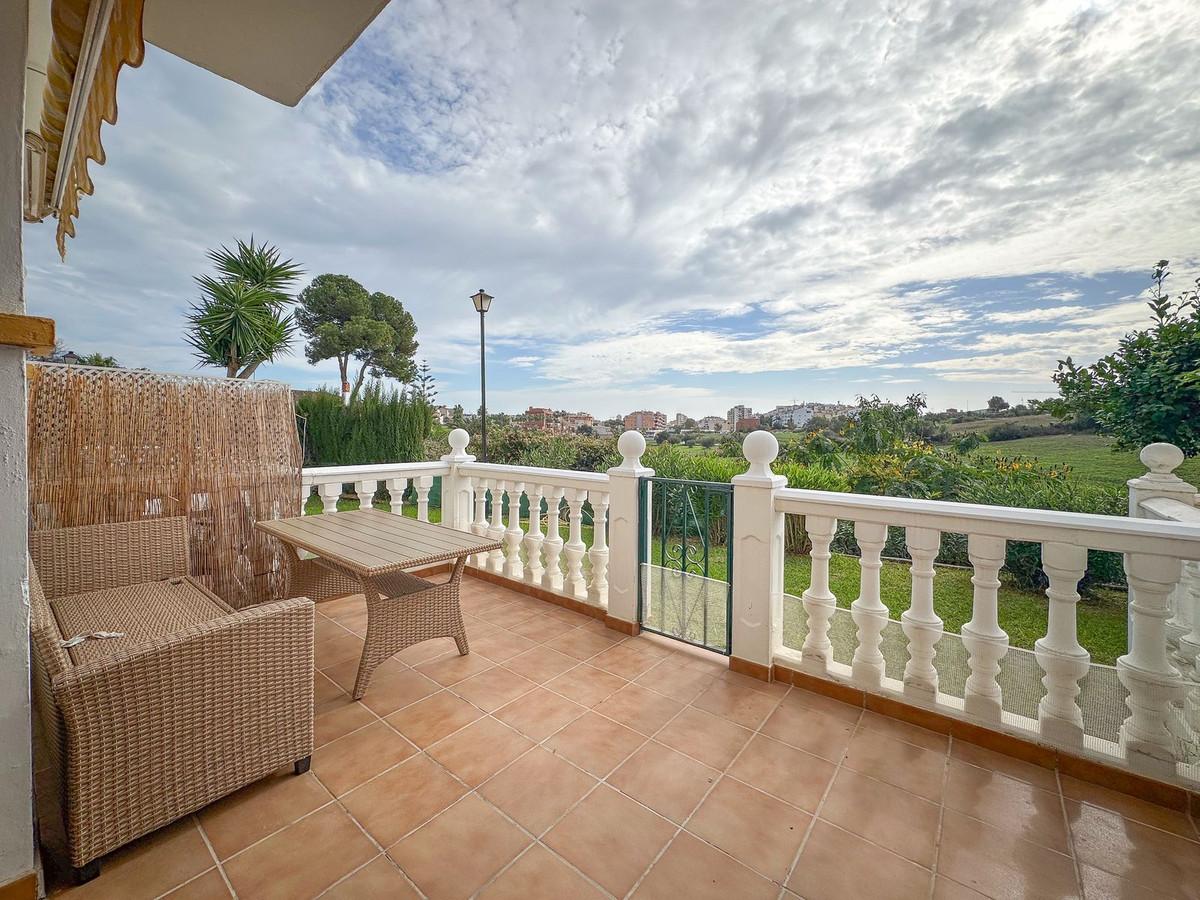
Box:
962;534;1008;722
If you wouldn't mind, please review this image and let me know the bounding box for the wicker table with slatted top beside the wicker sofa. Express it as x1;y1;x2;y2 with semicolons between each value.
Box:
256;509;502;700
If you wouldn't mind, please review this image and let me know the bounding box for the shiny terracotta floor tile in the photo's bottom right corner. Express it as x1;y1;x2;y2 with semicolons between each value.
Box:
1067;800;1200;898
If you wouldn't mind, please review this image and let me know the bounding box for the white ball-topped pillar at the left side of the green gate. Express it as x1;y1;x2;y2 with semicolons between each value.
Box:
608;431;654;632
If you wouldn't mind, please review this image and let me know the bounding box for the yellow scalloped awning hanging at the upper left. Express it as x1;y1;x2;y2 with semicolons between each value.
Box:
41;0;145;257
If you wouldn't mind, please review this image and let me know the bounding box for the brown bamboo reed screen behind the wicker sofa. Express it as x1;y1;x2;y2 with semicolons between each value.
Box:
29;364;300;607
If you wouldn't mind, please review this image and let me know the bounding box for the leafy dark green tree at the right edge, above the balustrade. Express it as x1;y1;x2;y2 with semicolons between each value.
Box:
1043;259;1200;456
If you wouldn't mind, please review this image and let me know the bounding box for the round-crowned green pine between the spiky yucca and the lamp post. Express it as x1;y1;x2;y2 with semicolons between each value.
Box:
296;275;416;403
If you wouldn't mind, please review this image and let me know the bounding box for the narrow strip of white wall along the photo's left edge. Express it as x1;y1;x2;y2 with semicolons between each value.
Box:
0;0;35;886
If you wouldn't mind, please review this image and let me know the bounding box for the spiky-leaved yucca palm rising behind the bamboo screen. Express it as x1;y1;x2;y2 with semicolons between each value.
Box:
187;238;302;378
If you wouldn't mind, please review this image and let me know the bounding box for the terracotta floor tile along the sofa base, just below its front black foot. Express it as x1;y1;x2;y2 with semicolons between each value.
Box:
199;768;334;859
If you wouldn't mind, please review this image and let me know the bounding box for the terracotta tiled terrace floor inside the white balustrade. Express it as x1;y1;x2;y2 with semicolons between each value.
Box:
42;578;1200;900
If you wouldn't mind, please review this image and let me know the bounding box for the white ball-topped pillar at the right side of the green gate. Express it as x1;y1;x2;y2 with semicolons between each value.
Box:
730;431;787;680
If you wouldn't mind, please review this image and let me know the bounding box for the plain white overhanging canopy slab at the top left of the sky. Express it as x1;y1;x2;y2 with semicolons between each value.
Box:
143;0;388;107
